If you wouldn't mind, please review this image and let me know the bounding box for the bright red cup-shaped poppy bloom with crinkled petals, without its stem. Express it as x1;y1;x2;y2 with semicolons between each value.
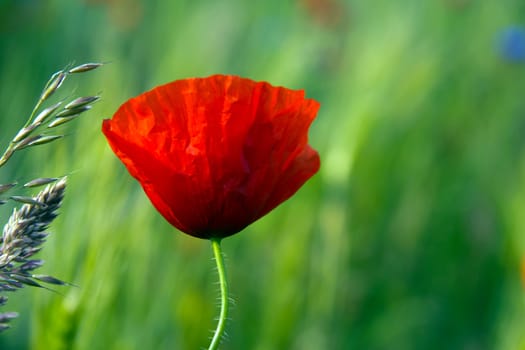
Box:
102;75;319;238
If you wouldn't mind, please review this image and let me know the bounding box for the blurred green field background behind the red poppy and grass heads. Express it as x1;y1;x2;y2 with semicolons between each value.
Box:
0;0;525;350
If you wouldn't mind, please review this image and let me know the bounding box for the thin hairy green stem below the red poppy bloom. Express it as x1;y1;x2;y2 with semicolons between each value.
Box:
208;238;228;350
